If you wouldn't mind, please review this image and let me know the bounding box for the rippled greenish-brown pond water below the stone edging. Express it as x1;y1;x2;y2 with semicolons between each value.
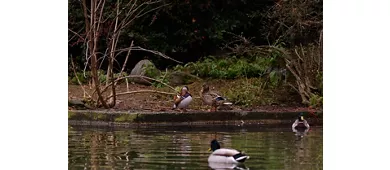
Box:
68;126;322;170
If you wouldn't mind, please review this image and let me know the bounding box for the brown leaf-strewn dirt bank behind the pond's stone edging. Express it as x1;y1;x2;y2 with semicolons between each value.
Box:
68;80;316;112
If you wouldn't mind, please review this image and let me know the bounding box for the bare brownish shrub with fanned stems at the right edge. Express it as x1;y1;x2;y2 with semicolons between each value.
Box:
219;31;323;104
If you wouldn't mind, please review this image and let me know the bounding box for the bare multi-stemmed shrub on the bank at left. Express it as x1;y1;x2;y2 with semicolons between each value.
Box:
76;0;181;108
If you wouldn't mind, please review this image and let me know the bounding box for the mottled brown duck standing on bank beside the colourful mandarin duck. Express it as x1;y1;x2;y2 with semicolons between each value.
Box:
200;84;232;111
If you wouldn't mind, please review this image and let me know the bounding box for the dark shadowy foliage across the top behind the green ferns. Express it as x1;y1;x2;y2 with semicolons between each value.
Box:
68;0;322;68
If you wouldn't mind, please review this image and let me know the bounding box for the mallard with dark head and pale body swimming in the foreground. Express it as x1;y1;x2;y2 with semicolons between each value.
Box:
208;139;249;164
